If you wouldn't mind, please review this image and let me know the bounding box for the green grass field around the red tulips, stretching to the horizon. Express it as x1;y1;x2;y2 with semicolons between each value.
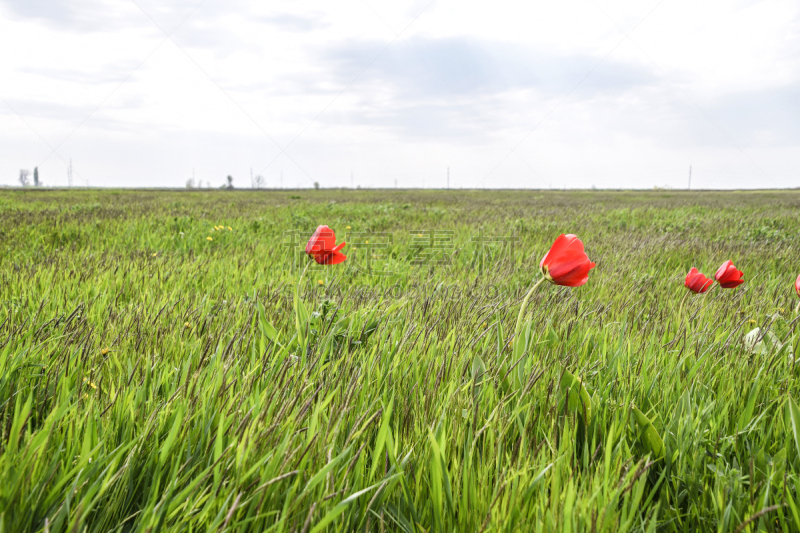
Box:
0;190;800;532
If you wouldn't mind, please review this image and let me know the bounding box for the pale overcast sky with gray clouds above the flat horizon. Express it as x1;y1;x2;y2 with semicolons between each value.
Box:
0;0;800;188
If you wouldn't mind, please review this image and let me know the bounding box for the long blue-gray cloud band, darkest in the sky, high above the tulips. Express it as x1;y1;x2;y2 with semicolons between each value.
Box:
328;38;656;98
